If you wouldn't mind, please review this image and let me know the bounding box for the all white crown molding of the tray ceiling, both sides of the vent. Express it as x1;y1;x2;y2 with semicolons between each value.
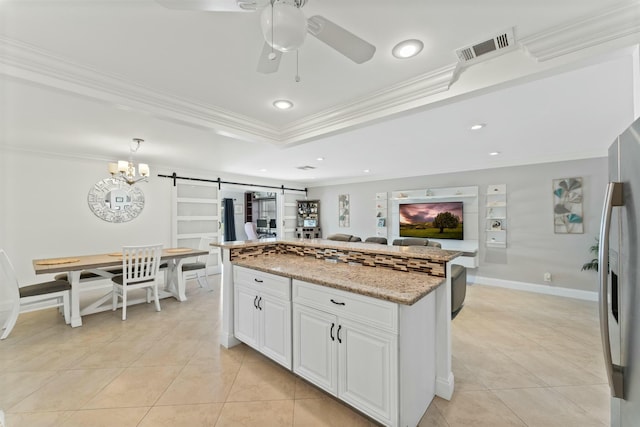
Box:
0;1;640;149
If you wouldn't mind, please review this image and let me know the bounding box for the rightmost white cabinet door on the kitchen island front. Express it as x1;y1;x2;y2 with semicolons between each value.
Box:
336;319;398;424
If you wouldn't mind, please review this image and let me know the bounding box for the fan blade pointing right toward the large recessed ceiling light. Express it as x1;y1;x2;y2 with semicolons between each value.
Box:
307;15;376;64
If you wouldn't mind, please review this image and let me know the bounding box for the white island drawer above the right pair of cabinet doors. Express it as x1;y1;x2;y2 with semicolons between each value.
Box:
293;279;398;334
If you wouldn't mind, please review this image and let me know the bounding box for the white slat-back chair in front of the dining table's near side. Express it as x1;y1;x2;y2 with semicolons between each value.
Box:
111;245;162;320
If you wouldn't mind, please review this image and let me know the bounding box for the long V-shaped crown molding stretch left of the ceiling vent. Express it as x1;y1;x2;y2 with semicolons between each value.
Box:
0;36;457;145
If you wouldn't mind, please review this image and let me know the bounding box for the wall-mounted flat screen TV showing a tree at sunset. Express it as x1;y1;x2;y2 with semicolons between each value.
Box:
399;202;464;240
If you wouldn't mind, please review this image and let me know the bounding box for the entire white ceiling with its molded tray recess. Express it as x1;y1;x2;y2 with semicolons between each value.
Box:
0;0;640;186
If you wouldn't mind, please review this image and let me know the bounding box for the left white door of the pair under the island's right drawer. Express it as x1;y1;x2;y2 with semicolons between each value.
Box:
293;304;338;396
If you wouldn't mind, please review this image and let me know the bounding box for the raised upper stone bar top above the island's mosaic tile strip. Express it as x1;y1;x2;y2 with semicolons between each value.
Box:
211;239;462;262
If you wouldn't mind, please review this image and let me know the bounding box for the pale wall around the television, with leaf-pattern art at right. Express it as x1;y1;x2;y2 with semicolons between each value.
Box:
309;158;607;291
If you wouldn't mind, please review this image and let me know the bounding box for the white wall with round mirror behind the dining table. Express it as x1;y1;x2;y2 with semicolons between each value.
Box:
0;147;300;286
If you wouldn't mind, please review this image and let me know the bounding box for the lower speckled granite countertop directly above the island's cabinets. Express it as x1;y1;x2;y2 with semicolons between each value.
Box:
233;252;445;305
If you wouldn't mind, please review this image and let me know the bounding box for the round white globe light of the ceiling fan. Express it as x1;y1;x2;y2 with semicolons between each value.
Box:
260;0;307;52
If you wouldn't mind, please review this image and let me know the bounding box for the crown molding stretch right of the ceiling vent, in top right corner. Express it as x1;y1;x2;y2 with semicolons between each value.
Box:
520;1;640;61
